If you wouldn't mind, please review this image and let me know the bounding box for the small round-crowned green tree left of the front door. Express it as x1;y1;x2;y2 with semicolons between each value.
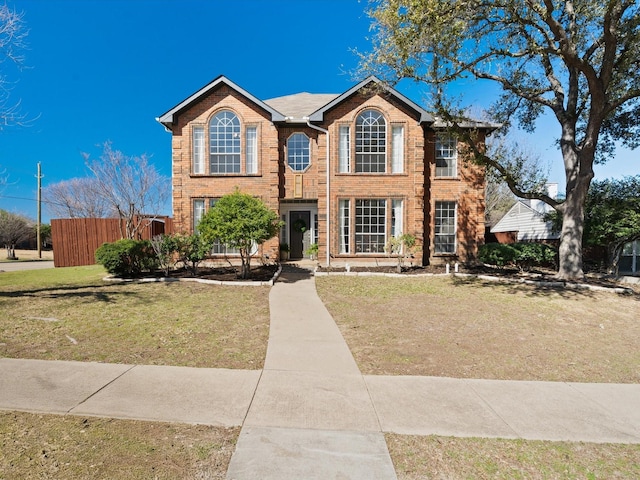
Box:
198;190;282;279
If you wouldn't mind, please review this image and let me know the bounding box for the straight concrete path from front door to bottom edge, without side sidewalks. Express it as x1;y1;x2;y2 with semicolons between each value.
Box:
227;267;396;480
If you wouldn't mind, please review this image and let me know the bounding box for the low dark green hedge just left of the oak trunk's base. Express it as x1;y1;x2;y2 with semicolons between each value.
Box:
478;243;557;270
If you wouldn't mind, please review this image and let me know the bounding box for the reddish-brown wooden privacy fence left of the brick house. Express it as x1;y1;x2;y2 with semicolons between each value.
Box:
51;217;173;267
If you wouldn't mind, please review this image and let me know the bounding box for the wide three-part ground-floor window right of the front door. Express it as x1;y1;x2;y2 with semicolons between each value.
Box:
338;198;402;254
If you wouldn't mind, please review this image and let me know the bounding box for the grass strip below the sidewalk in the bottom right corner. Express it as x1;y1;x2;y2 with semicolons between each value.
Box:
386;434;640;480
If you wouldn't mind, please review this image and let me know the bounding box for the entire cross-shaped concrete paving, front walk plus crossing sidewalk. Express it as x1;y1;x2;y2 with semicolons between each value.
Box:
0;264;640;480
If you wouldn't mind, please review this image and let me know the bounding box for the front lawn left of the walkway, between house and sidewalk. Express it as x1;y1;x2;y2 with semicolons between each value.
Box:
0;266;269;369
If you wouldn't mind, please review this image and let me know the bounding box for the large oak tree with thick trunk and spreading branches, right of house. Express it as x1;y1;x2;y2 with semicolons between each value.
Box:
362;0;640;279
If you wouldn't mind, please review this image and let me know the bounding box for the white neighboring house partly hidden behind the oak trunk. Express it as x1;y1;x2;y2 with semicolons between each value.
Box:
491;183;560;243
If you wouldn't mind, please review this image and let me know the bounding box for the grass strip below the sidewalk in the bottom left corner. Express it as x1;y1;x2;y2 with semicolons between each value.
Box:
0;412;240;480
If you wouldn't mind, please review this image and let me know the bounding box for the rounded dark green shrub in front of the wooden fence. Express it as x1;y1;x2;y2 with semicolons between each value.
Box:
95;239;157;277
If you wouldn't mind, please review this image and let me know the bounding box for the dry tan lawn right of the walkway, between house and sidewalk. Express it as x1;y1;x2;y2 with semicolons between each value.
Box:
316;276;640;383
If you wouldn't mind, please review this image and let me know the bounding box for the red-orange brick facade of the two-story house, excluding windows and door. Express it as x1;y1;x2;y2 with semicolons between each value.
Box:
172;81;484;264
